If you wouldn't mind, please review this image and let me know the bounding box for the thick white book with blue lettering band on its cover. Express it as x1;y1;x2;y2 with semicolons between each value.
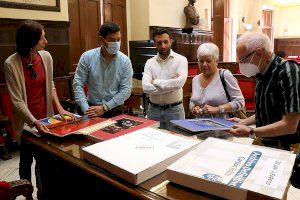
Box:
166;138;295;199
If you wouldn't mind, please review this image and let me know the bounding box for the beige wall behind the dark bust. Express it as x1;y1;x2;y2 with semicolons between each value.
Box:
127;0;211;40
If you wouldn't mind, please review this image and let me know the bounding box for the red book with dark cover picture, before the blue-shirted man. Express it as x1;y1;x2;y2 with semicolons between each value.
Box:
85;114;158;142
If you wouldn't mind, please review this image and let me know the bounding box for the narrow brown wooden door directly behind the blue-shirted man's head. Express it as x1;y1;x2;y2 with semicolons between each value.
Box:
103;0;127;54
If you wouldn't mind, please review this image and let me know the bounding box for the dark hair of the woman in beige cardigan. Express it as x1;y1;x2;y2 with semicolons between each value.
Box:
16;20;44;56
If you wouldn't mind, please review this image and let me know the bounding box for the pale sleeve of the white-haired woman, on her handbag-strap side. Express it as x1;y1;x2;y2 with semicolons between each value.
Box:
224;70;245;112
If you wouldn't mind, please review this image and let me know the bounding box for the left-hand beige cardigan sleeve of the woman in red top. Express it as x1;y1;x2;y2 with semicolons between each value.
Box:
4;63;37;127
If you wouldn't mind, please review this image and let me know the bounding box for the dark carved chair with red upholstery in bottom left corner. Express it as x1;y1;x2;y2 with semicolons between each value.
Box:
0;179;33;200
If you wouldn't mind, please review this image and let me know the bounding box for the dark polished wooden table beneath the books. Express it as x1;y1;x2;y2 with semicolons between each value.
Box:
22;130;276;200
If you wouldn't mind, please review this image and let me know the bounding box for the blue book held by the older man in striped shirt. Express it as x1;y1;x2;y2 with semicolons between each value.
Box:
171;118;236;133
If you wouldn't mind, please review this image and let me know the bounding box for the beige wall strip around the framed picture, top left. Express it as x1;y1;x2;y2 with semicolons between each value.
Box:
0;0;69;21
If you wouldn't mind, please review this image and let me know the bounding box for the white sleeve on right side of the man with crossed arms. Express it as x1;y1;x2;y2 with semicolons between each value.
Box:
153;57;188;92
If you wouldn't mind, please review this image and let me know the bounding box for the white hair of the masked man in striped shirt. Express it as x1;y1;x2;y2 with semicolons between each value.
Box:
237;32;272;52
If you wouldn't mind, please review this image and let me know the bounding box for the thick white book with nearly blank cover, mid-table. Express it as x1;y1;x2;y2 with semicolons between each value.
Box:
82;127;200;185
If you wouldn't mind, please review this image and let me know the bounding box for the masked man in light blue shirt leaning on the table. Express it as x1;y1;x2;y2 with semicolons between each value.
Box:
73;22;133;117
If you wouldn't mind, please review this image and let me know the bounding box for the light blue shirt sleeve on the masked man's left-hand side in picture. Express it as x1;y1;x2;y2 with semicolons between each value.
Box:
73;54;89;112
